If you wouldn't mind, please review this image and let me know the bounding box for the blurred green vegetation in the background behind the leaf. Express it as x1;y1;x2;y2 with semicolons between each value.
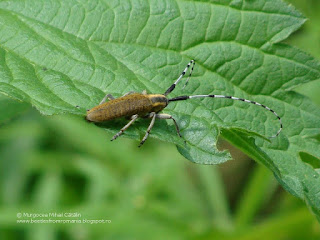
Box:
0;0;320;240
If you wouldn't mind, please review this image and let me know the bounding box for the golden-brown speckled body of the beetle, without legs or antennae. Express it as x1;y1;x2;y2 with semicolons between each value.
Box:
86;93;168;122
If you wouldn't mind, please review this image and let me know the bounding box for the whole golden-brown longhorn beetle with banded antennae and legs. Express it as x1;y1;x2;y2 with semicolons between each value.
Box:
86;60;282;147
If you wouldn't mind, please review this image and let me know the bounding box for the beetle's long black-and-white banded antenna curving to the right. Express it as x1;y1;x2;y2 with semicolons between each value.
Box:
168;95;283;138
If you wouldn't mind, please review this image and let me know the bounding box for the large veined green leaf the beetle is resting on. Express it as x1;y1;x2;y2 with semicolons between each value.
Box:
0;0;320;218
